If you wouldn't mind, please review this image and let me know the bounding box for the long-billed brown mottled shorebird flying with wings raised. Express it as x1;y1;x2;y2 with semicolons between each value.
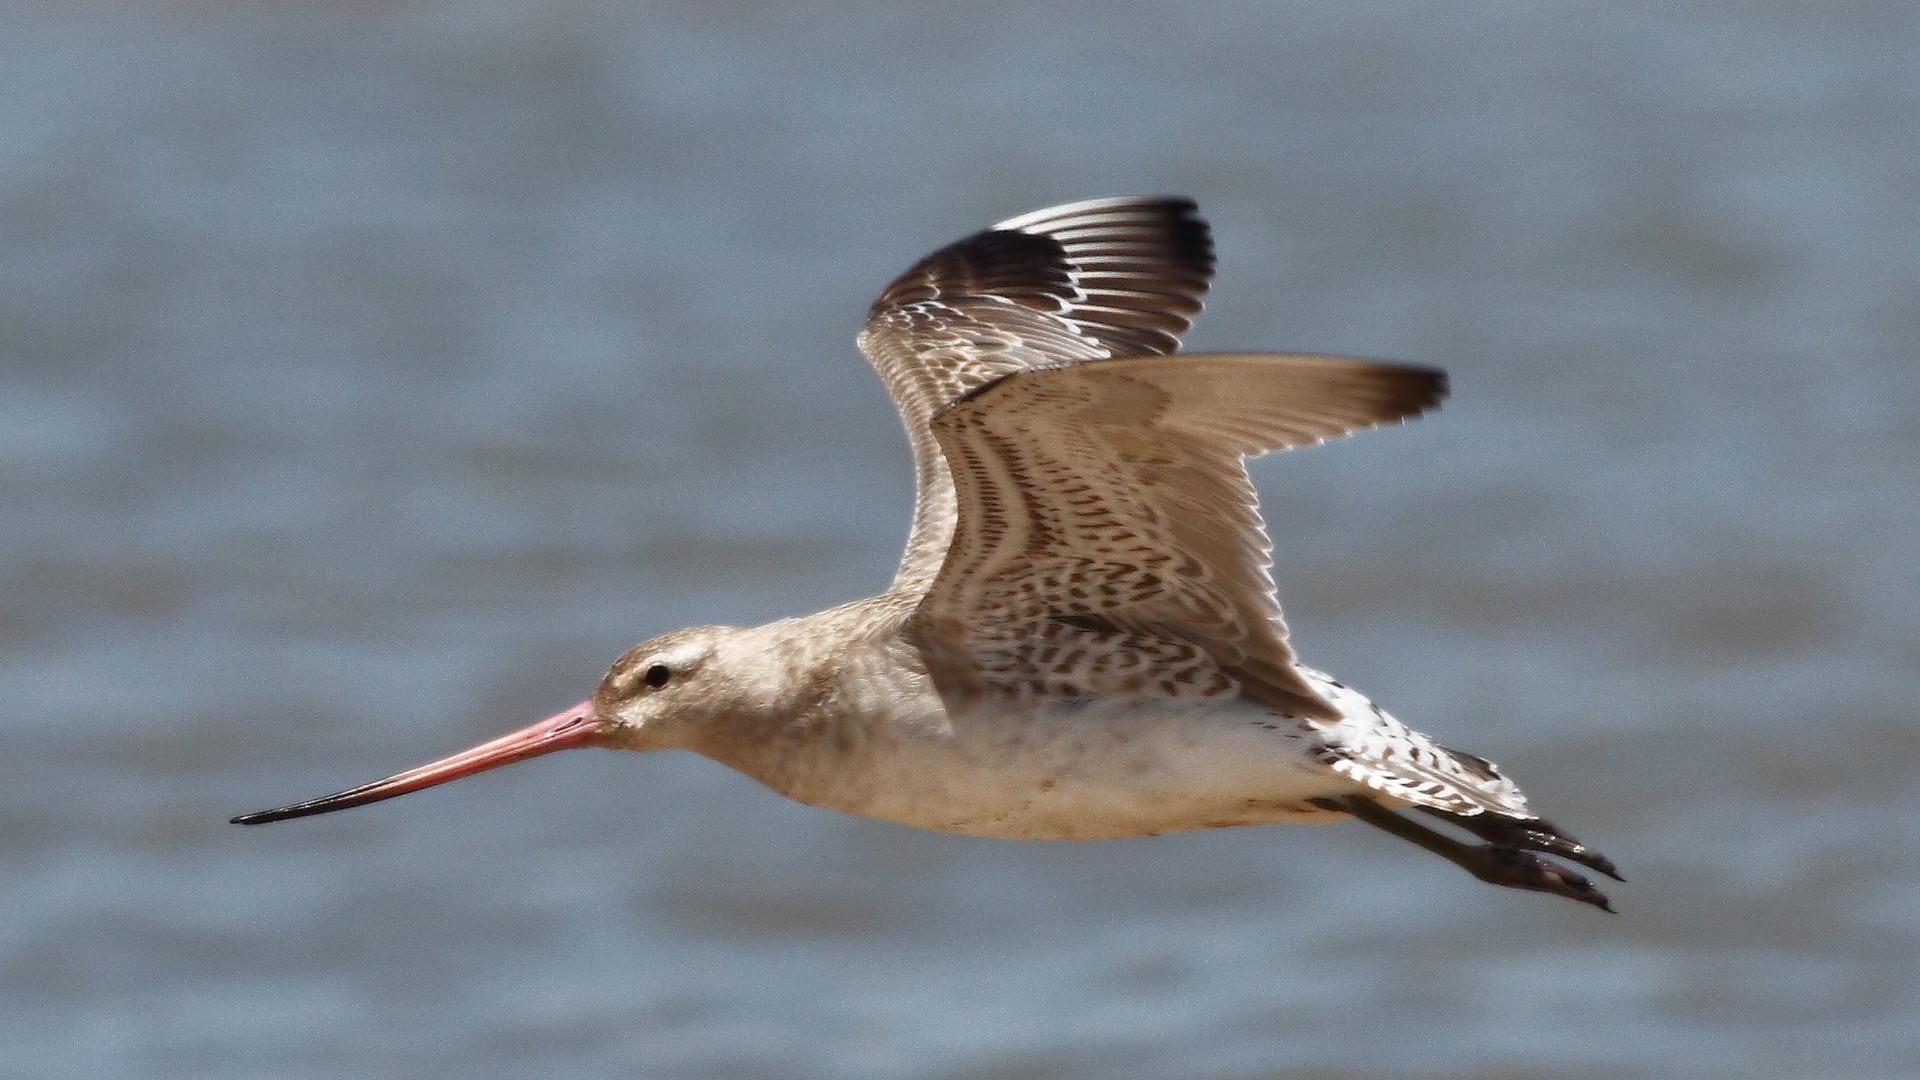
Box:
234;198;1619;911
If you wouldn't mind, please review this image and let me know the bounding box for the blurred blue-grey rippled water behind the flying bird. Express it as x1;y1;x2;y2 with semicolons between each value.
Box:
0;0;1920;1080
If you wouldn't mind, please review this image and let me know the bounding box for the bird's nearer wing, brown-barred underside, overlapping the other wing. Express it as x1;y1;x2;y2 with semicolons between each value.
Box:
910;354;1446;719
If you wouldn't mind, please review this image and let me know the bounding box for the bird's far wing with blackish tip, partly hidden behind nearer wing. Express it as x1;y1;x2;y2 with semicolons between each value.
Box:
860;198;1213;594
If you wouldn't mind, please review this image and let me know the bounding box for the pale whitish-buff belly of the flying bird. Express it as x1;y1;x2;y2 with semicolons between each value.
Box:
787;701;1350;840
